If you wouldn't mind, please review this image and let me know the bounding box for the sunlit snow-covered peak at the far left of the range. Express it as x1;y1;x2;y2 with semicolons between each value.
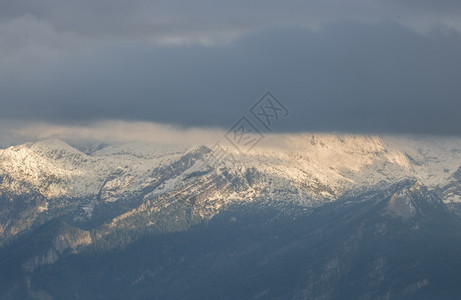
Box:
0;140;185;198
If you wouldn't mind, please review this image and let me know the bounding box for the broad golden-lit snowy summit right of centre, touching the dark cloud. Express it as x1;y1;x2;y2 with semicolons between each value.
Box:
234;134;411;197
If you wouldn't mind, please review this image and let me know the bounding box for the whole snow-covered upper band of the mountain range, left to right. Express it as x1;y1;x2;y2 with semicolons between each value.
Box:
0;134;461;207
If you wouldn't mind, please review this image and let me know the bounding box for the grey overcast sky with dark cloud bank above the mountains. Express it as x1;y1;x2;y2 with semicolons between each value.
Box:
0;0;461;137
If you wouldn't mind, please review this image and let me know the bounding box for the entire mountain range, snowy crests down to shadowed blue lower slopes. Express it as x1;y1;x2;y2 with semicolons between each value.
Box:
0;134;461;299
